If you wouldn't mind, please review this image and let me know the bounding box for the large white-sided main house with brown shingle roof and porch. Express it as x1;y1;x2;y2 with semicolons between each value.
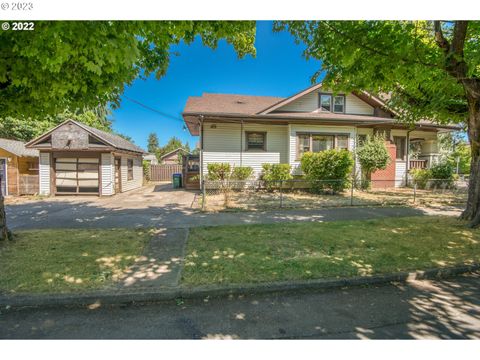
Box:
182;84;458;186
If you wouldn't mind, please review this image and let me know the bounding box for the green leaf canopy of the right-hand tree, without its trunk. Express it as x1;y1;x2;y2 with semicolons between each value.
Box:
274;21;480;123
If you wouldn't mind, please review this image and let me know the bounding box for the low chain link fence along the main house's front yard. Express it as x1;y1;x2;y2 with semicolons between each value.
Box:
199;179;468;211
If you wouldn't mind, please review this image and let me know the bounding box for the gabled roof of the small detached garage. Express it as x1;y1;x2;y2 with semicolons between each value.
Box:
26;119;145;154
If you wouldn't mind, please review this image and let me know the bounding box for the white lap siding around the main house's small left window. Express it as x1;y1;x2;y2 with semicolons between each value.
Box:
203;123;288;176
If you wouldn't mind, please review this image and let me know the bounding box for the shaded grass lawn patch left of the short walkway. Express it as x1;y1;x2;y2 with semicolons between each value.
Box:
0;229;150;292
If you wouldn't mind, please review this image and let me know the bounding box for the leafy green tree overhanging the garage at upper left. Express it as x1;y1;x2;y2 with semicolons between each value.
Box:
0;21;255;240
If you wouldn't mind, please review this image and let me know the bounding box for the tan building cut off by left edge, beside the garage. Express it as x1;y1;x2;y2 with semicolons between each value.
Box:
0;139;38;195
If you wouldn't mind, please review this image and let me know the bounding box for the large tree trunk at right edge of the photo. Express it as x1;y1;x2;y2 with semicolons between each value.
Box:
460;96;480;227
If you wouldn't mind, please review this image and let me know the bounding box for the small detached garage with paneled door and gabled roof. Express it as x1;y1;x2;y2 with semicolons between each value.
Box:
26;120;145;196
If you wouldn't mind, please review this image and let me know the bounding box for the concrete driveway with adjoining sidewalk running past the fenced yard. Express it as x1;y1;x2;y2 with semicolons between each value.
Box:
6;183;459;230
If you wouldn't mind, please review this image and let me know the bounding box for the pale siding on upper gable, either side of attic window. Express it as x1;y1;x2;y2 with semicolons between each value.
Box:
276;91;374;115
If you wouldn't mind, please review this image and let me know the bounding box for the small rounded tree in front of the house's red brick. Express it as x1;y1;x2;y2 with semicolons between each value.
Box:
355;135;390;187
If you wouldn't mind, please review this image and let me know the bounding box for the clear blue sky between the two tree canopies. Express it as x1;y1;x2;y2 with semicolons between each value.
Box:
112;21;320;149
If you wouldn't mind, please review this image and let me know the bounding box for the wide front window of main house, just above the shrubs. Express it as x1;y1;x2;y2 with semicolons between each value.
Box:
297;134;349;159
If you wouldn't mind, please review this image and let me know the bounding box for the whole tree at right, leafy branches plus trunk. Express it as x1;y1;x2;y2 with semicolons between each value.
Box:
274;21;480;226
